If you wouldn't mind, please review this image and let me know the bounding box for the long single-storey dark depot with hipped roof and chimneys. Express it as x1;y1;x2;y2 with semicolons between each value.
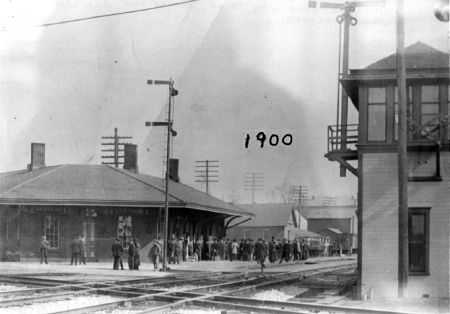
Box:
0;143;251;260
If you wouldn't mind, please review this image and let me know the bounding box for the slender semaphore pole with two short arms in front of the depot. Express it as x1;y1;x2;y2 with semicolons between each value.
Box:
145;79;178;272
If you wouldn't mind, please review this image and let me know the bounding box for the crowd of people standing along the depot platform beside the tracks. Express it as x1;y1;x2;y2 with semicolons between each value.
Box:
40;235;309;271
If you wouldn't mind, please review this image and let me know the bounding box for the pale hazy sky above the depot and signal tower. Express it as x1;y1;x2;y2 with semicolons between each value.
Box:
0;0;448;202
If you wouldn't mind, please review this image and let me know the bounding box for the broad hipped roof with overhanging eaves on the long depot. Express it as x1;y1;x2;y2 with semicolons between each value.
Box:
0;165;253;217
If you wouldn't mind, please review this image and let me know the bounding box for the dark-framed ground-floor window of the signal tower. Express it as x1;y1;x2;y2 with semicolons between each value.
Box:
408;208;430;275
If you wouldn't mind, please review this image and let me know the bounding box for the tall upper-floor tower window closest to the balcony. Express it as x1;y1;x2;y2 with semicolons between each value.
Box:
367;87;386;142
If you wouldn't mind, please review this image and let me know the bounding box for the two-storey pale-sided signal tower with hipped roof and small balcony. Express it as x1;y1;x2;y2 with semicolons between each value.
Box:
326;42;450;298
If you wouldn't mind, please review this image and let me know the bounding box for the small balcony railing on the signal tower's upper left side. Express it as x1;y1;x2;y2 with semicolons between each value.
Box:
328;124;358;152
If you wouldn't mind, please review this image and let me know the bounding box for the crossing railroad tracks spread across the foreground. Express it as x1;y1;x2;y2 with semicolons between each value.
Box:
0;263;412;314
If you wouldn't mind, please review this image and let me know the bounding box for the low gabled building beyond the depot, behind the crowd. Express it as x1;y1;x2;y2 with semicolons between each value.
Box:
226;203;307;240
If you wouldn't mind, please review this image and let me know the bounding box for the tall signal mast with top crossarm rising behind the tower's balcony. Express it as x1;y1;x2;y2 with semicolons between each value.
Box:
308;0;384;177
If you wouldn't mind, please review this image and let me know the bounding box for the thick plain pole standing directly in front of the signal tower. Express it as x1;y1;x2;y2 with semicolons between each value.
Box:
396;0;409;298
